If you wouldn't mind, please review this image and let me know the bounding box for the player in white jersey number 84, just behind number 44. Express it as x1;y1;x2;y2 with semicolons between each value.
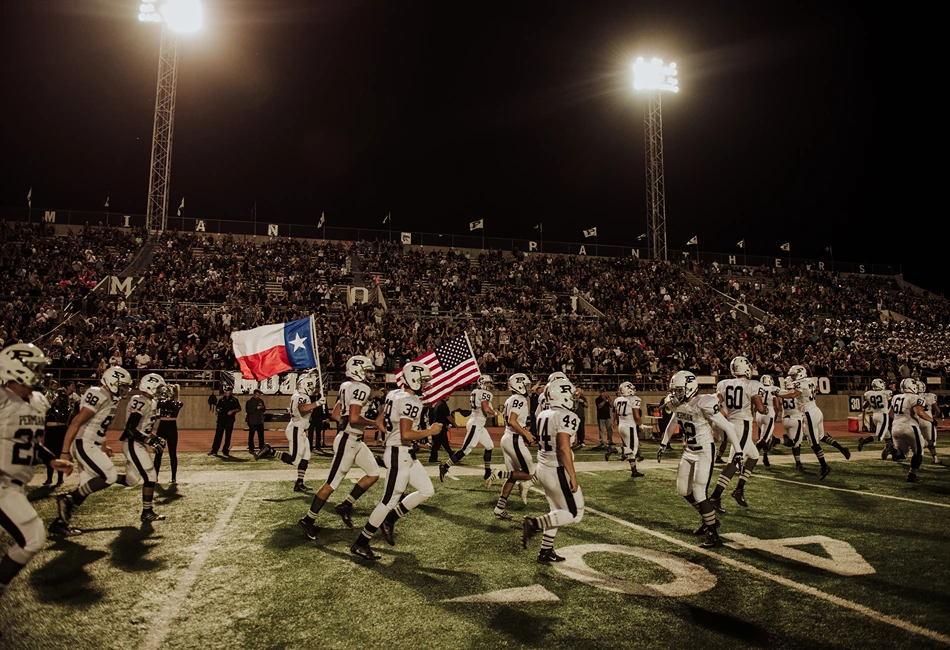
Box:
495;372;538;519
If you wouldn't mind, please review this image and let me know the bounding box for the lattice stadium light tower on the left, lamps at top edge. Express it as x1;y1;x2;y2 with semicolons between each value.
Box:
139;0;202;232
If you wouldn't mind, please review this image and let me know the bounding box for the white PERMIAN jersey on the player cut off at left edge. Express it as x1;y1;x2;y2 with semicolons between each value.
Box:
0;386;49;483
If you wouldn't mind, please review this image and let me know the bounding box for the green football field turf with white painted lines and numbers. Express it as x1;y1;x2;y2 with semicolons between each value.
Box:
0;440;950;650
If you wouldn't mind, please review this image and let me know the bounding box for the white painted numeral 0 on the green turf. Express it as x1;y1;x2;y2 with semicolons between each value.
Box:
551;544;717;597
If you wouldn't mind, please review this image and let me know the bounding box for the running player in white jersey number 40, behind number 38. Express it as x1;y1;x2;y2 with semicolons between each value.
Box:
297;355;379;539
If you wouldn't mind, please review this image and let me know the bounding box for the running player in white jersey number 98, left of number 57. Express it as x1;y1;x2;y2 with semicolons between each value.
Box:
49;366;132;535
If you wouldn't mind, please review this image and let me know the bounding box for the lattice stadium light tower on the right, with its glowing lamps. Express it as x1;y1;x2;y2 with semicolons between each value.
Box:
633;56;679;260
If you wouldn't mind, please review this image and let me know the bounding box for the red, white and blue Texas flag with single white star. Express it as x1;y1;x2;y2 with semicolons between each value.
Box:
231;316;317;381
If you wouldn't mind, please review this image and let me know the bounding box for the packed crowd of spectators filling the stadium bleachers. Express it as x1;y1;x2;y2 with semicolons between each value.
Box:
0;225;950;387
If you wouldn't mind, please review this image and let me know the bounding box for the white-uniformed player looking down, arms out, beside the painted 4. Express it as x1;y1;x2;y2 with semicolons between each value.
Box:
656;370;742;548
